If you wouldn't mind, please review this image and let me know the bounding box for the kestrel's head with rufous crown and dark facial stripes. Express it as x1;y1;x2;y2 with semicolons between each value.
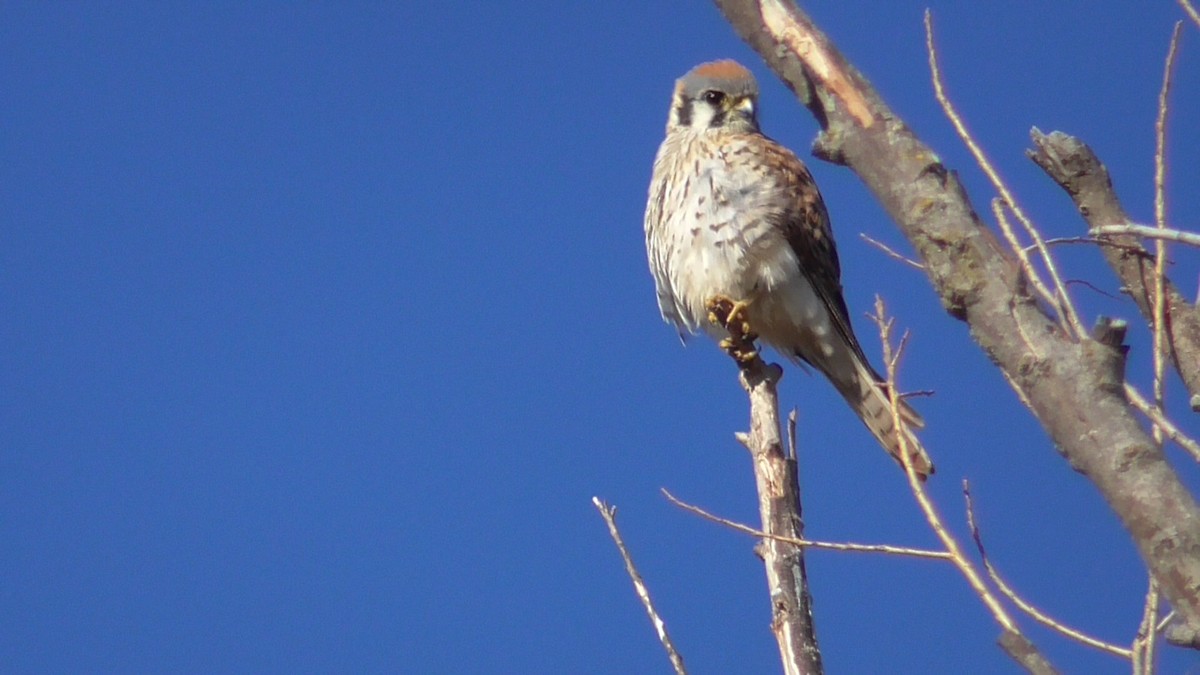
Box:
667;61;758;131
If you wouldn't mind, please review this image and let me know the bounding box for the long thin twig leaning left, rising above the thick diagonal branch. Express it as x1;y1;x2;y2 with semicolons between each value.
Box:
925;10;1087;338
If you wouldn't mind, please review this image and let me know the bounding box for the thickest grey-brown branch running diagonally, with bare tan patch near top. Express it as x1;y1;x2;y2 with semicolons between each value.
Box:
715;0;1200;649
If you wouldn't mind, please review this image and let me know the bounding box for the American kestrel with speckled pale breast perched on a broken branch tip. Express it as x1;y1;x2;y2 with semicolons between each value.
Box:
646;61;934;477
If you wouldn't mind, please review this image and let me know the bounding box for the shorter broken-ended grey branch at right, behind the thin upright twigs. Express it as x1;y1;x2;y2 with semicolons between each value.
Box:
1025;129;1200;408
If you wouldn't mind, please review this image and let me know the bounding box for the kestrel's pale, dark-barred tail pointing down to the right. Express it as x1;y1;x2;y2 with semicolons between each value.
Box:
829;358;934;480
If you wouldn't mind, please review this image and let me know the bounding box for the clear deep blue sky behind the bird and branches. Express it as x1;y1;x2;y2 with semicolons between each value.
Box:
0;0;1200;674
